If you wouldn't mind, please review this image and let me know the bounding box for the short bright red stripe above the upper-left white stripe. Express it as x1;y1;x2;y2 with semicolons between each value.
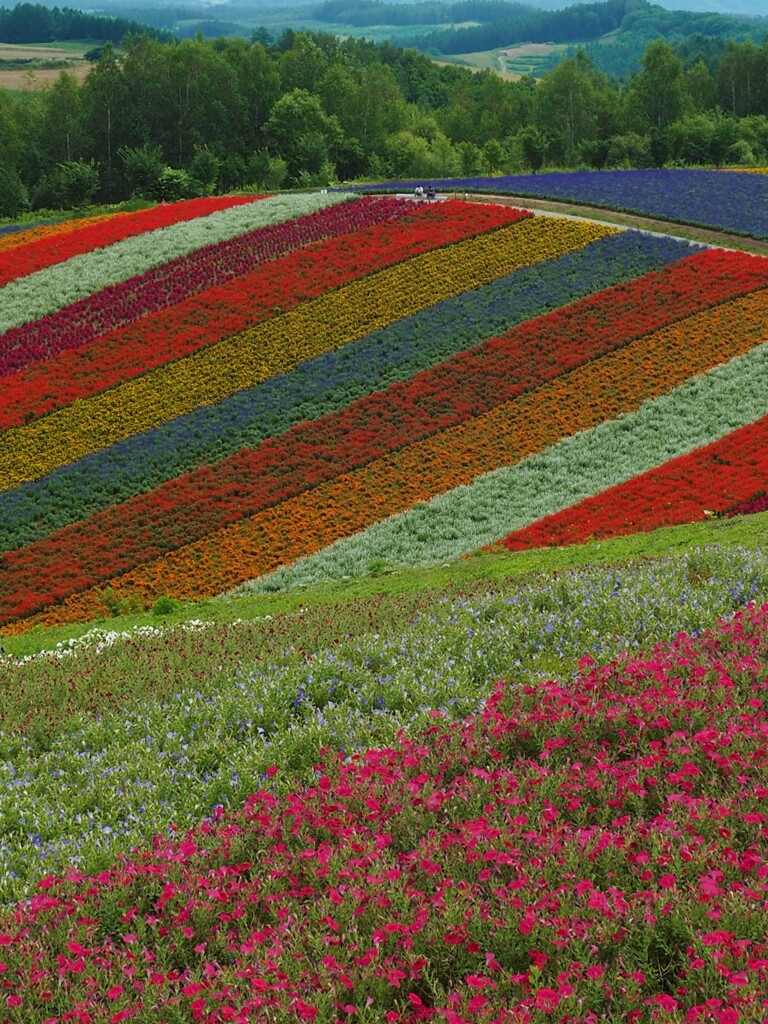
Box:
0;196;262;286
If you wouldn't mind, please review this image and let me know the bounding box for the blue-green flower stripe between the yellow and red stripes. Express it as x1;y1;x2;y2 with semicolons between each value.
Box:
0;232;696;551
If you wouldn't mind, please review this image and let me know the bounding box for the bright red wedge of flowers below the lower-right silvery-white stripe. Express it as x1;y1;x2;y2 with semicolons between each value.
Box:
501;417;768;551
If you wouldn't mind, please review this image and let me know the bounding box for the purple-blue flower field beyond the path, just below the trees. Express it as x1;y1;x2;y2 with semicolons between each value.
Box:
361;168;768;238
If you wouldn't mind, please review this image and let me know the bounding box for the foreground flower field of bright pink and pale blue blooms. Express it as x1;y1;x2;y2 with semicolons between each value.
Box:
0;565;768;1024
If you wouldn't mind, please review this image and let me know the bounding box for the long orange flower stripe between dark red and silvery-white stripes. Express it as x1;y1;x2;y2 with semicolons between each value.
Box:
9;280;768;634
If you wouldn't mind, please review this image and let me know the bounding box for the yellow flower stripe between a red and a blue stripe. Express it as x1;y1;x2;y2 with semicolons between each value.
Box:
0;217;614;489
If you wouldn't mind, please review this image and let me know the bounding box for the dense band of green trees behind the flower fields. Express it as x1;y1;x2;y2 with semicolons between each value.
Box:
0;24;768;217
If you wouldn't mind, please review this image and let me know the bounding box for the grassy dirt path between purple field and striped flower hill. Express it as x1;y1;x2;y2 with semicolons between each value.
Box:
467;193;768;256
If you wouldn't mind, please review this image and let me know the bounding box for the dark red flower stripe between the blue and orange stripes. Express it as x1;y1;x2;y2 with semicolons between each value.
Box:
0;251;765;622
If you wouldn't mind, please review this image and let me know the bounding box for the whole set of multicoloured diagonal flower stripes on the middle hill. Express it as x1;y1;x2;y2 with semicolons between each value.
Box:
0;187;768;631
